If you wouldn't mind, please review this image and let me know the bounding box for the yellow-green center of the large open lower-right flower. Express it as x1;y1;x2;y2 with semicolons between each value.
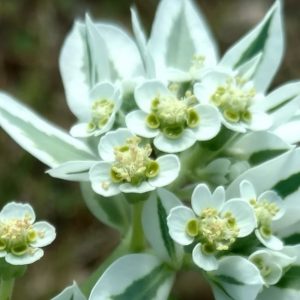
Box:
186;208;239;254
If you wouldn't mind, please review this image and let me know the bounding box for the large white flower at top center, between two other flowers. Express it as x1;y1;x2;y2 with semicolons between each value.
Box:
126;80;220;153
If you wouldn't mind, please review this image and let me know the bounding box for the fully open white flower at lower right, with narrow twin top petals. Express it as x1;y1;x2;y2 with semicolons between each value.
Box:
167;184;256;271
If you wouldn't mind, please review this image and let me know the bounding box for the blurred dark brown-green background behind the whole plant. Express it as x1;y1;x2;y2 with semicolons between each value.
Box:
0;0;300;300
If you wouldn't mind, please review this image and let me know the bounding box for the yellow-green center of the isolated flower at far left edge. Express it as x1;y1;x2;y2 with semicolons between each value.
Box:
0;216;44;256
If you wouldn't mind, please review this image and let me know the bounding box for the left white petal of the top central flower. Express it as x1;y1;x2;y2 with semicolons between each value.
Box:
125;110;159;138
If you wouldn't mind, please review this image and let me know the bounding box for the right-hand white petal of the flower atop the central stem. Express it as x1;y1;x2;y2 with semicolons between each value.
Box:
148;154;180;187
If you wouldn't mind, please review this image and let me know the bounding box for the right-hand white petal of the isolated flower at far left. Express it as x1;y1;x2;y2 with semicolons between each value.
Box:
30;221;56;248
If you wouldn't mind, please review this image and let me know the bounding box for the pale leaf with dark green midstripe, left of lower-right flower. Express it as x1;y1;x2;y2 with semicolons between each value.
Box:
142;189;183;265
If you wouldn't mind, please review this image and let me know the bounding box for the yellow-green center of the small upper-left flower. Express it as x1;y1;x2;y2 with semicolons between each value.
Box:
87;99;115;132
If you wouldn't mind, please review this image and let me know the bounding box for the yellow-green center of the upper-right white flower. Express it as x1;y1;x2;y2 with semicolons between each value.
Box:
211;77;256;123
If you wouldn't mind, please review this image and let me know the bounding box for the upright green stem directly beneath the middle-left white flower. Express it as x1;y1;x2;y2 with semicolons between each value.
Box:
129;201;145;252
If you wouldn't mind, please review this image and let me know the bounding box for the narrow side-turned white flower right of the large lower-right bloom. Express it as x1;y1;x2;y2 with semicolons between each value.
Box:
240;180;285;250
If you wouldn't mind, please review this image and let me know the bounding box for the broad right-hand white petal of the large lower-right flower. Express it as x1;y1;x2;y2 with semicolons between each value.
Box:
222;199;256;237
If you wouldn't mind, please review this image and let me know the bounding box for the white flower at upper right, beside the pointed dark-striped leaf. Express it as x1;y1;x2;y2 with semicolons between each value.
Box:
194;71;272;132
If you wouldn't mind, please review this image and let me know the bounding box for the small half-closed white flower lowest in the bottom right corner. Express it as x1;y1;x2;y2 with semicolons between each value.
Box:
249;249;296;287
